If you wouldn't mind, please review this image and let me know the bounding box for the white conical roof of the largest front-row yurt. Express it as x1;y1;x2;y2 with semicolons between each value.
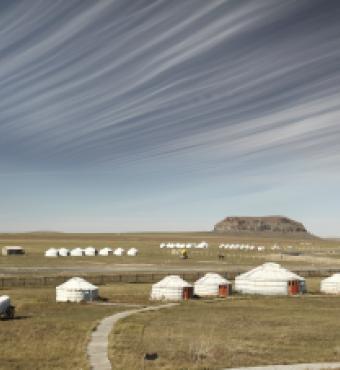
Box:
236;262;304;281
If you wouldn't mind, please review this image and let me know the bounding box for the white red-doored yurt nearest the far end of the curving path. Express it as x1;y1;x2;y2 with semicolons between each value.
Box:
150;275;193;301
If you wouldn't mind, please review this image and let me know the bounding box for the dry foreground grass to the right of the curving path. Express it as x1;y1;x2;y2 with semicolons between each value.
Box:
109;279;340;370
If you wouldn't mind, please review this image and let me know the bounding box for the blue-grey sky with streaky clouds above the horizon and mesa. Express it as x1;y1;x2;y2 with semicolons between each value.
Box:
0;0;340;236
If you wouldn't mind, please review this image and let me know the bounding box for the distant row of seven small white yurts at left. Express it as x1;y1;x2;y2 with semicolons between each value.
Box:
45;247;138;257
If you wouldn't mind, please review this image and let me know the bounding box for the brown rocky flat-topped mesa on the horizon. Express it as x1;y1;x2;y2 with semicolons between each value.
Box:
214;216;307;234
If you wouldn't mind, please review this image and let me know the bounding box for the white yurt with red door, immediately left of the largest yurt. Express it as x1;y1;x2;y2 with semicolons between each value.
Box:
194;273;231;297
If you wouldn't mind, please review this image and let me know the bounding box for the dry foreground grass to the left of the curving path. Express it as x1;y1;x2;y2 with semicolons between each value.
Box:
0;284;149;370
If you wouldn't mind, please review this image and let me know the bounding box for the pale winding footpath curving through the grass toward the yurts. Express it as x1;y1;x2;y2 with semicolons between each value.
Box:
87;303;178;370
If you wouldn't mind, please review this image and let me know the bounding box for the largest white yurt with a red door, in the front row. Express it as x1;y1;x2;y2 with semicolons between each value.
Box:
235;262;305;295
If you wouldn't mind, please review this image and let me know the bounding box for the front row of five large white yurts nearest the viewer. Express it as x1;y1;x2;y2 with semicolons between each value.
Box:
56;263;340;302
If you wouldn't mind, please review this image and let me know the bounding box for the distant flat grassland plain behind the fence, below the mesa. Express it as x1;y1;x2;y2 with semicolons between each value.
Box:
0;233;340;275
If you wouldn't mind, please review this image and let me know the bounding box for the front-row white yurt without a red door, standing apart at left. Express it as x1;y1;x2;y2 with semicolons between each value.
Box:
56;277;98;302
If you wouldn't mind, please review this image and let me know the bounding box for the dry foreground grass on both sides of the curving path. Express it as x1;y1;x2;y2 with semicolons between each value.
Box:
0;278;340;370
